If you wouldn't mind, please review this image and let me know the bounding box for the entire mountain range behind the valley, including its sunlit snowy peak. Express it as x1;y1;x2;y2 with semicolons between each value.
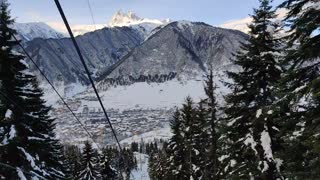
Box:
16;12;246;88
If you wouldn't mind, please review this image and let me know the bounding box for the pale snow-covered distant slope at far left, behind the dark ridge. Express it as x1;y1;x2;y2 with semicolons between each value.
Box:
13;22;65;42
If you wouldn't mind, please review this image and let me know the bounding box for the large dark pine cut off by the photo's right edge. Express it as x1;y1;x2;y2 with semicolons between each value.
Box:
278;0;320;179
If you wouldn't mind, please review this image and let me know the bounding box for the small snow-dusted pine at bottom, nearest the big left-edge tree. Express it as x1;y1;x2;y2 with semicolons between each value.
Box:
78;141;101;180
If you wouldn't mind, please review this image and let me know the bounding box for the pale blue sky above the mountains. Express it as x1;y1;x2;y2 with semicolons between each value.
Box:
9;0;282;25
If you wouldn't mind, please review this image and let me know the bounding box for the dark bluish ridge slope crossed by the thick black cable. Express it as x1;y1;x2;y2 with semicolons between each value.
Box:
27;27;144;84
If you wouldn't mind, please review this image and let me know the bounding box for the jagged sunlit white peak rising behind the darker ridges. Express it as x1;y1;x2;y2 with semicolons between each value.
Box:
109;11;170;27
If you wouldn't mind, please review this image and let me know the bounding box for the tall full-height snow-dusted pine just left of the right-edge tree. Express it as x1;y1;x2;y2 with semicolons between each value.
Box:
225;0;281;179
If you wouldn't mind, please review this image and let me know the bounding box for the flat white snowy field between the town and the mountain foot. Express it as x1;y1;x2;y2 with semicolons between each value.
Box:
76;80;204;110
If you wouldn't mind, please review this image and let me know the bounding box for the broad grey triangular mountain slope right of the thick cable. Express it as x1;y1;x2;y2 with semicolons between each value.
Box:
99;21;247;83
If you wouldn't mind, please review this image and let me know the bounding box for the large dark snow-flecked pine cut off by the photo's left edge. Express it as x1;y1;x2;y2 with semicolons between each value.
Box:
0;0;64;179
